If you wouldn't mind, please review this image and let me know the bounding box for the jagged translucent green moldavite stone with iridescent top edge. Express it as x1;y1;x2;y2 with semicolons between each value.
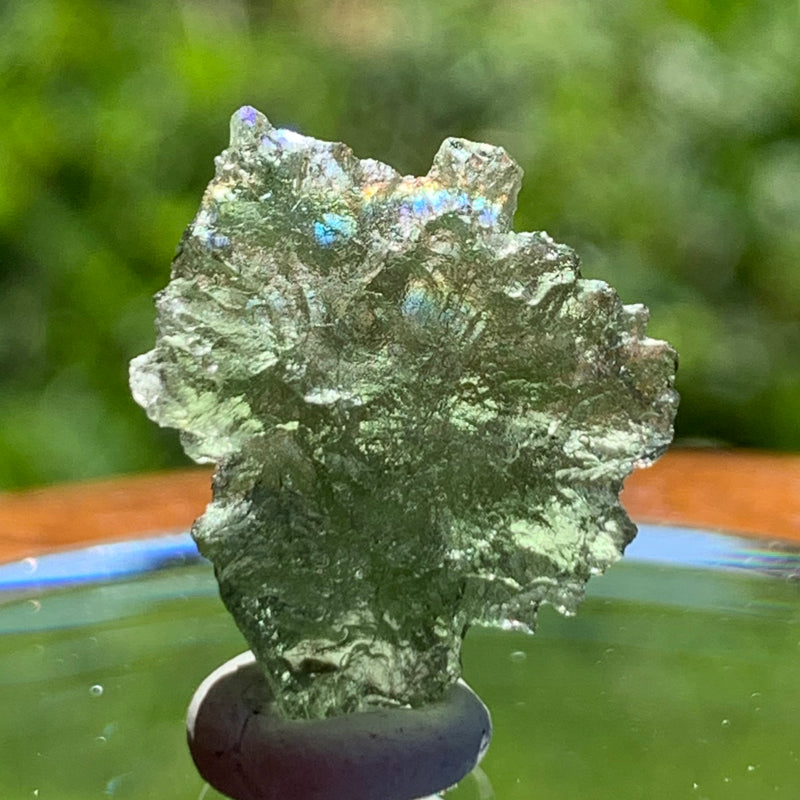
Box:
131;107;677;717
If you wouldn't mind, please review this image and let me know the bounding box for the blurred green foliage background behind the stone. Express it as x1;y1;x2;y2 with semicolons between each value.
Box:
0;0;800;488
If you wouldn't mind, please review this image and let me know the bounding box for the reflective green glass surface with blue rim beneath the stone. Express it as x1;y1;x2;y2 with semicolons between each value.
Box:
0;527;800;800
